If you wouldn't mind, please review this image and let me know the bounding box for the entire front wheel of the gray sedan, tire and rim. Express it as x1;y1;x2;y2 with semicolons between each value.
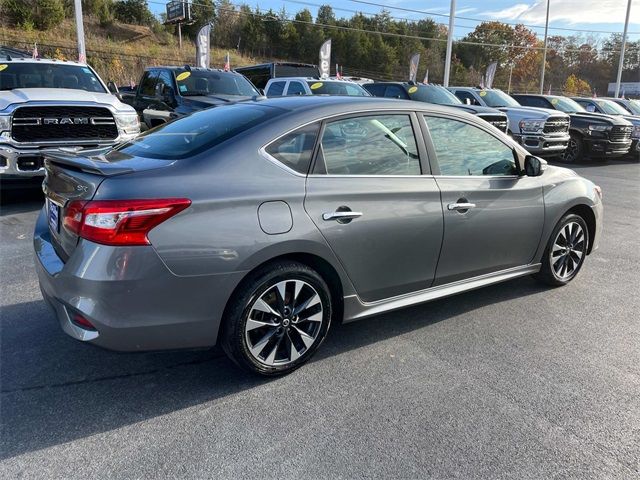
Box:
535;213;589;286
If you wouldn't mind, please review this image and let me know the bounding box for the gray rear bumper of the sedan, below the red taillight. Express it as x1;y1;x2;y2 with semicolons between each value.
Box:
34;209;244;351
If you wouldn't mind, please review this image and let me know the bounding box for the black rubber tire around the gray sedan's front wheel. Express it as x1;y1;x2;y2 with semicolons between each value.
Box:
533;213;591;287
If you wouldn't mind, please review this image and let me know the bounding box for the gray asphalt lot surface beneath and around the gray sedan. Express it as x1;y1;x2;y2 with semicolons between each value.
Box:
0;161;640;479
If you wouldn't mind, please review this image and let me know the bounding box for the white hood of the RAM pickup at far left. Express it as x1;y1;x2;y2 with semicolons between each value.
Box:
0;88;135;112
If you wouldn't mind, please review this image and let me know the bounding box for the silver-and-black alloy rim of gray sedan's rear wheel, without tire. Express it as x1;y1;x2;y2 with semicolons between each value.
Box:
244;279;324;367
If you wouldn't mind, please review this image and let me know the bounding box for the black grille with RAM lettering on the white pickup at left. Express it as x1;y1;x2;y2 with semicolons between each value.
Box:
11;106;118;142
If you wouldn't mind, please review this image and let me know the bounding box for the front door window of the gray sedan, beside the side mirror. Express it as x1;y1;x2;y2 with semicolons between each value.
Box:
424;115;518;176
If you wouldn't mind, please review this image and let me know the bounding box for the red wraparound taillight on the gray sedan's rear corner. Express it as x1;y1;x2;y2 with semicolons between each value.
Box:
63;198;191;245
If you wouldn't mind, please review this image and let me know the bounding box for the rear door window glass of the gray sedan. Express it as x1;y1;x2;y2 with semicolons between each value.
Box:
314;114;421;175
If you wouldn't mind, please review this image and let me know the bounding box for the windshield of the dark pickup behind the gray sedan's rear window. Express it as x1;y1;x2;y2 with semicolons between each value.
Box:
174;69;260;97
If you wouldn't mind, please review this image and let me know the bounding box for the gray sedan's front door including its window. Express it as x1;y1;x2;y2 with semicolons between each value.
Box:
422;114;544;285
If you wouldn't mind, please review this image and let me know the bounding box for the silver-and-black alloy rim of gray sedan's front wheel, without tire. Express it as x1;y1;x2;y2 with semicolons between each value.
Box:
550;222;587;280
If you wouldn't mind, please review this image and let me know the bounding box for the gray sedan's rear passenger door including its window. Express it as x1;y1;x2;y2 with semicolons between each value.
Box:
305;112;443;302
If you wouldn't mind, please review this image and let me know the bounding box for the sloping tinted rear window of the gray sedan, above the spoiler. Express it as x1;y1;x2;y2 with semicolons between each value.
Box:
116;104;283;160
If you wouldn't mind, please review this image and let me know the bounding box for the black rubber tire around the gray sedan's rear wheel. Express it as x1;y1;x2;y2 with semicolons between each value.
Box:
222;261;333;376
